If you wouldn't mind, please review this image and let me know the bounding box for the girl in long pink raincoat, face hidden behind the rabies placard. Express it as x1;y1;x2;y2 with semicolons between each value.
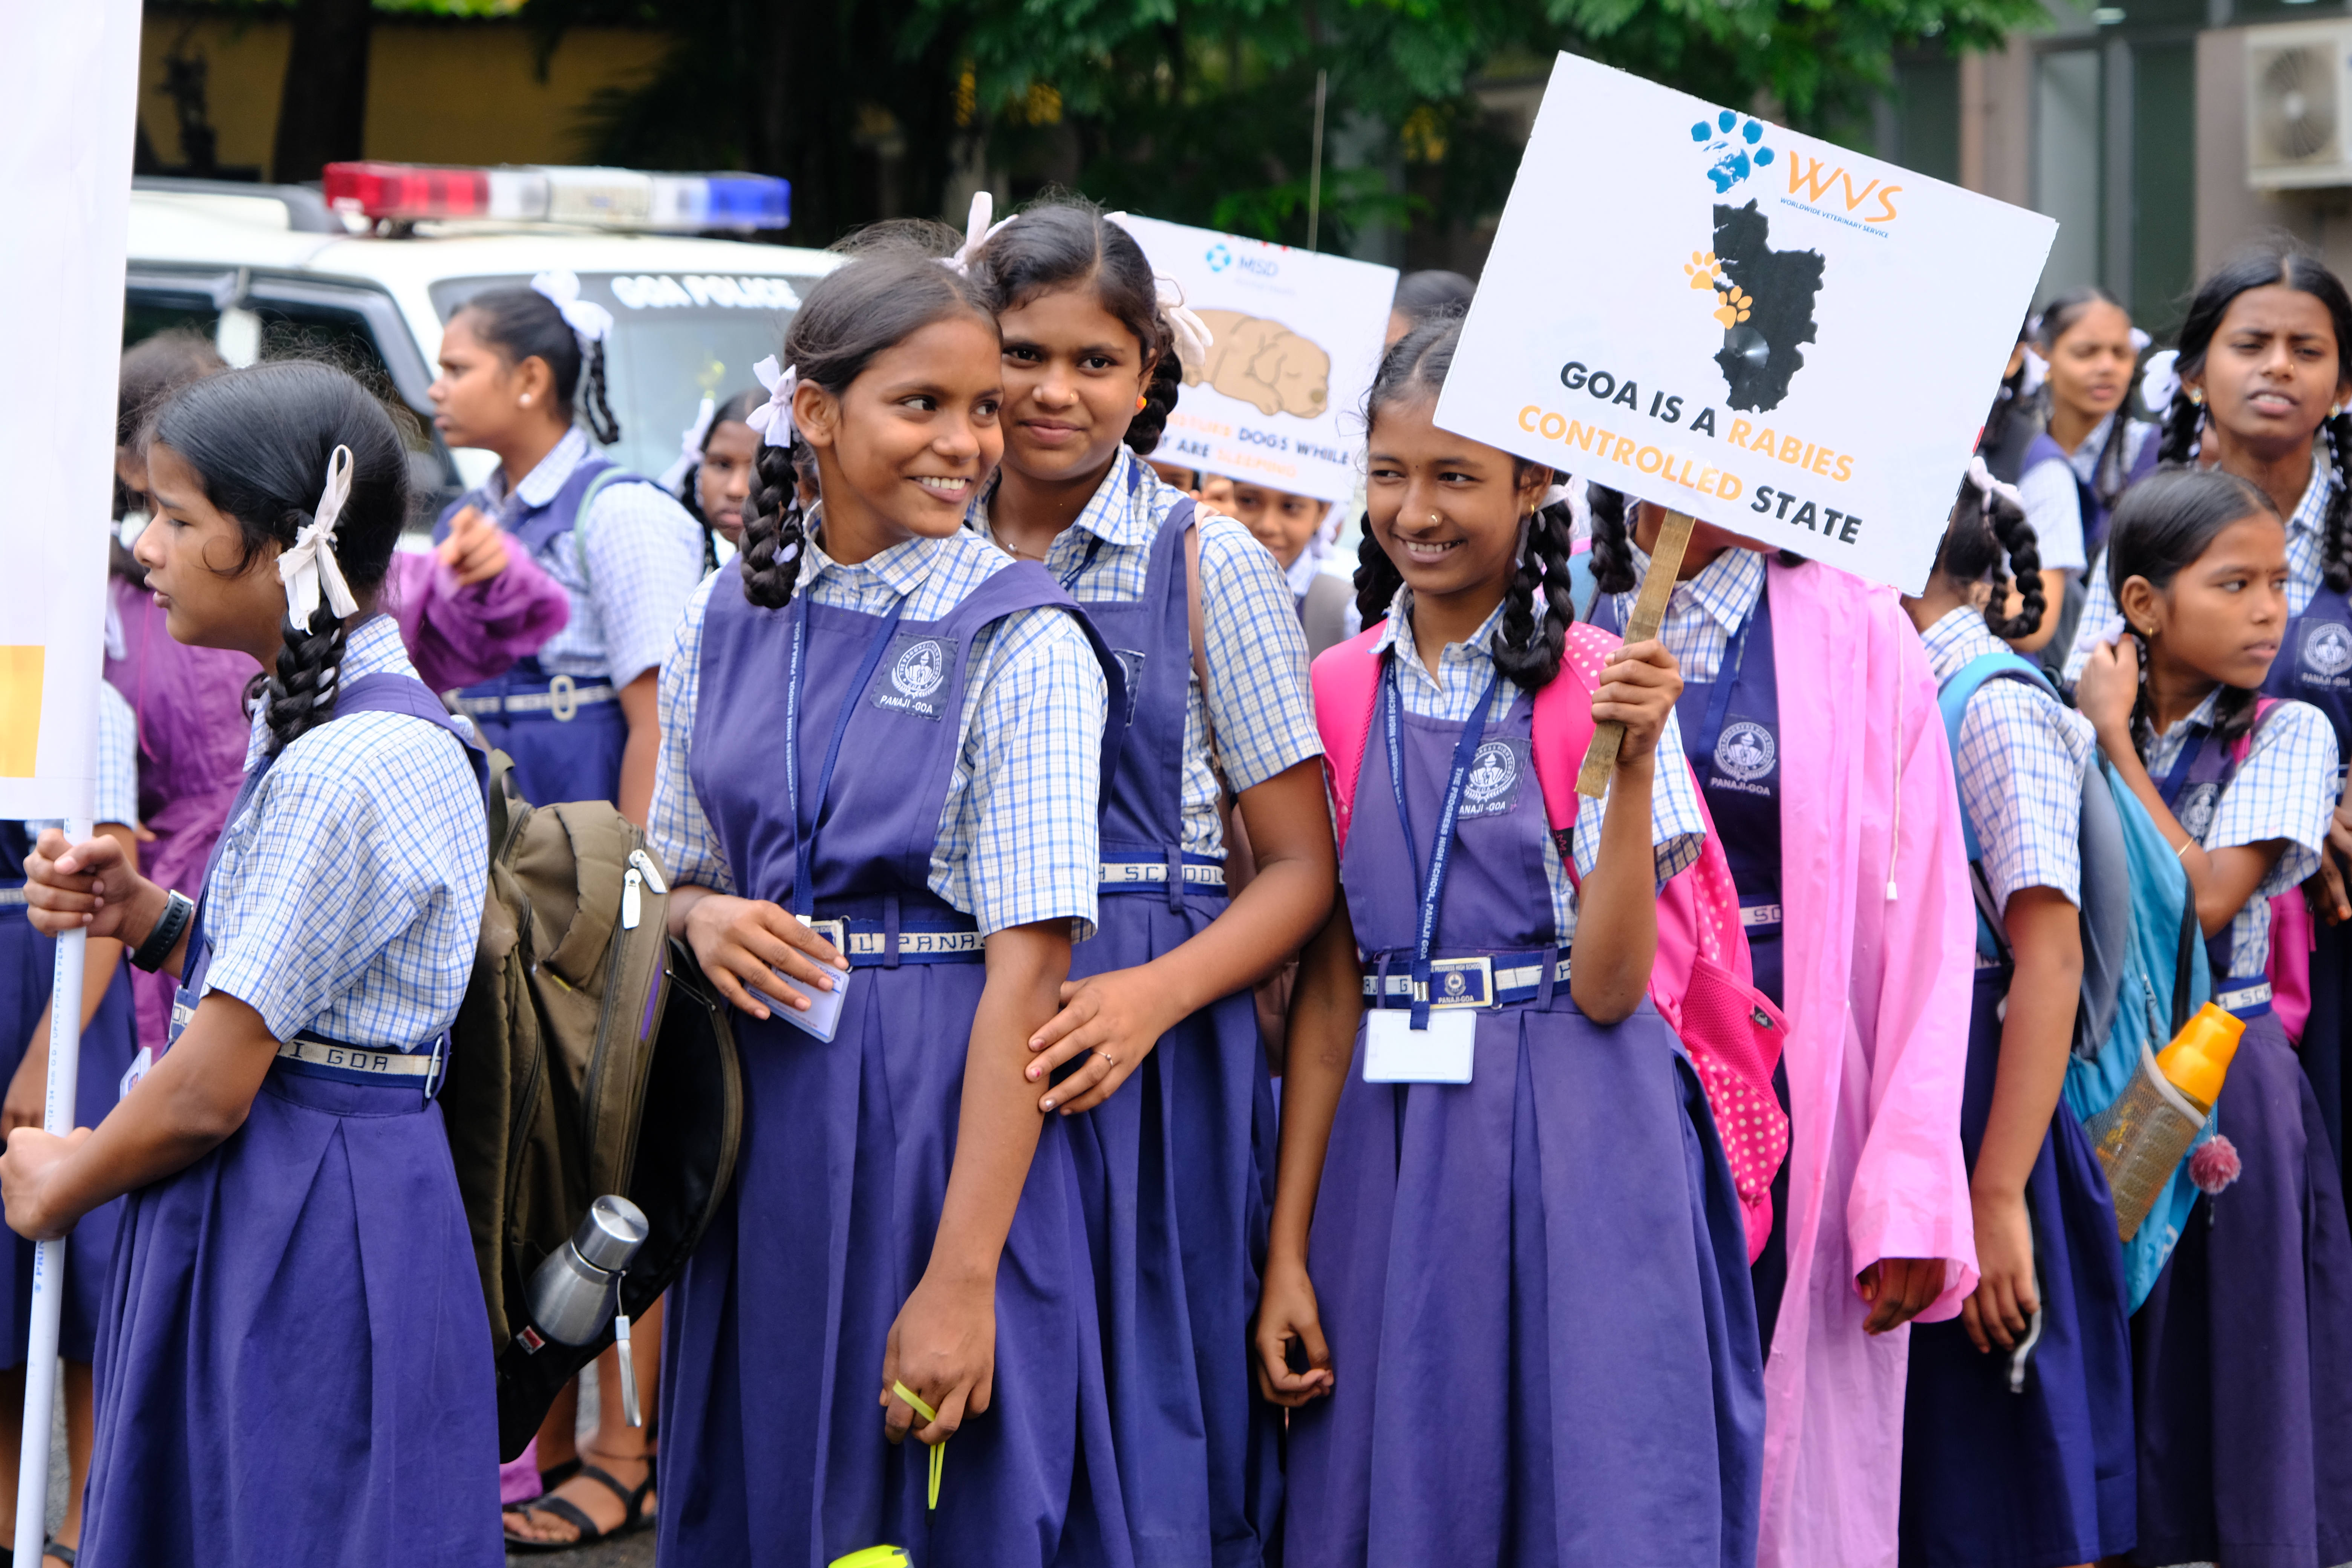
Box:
1588;487;1976;1568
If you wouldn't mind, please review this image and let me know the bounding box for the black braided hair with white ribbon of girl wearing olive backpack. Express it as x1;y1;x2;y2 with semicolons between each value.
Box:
144;360;409;752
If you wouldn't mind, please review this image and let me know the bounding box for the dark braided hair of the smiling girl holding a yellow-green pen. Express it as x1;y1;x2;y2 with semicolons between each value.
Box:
741;245;997;609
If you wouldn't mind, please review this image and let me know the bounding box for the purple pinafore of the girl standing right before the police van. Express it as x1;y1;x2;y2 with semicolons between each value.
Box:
433;456;651;806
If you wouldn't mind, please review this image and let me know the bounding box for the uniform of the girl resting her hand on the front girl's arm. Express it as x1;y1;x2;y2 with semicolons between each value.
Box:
971;447;1322;1568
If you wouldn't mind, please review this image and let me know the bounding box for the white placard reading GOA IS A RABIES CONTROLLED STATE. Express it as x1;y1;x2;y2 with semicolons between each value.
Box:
1437;54;2058;593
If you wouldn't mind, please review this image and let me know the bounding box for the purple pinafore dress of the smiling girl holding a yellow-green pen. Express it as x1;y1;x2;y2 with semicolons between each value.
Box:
658;564;1134;1568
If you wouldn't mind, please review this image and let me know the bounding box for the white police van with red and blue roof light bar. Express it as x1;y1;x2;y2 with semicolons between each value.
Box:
122;162;837;510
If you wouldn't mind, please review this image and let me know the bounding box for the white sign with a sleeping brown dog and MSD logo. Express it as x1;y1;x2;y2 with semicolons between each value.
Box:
1119;216;1397;501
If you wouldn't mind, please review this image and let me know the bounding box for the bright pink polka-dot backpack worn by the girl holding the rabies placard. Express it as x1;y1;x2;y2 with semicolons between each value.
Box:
1315;623;1787;1262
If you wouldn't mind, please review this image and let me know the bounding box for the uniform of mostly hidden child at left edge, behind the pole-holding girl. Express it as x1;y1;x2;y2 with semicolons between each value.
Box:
0;684;139;1366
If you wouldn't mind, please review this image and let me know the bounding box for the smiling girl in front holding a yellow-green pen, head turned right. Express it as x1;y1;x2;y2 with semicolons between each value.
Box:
651;251;1131;1568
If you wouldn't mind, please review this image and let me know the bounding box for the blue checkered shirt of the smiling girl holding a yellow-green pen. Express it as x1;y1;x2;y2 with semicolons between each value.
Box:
647;527;1110;938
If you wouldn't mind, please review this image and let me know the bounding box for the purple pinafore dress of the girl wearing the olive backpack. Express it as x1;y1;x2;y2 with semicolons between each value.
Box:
68;675;506;1568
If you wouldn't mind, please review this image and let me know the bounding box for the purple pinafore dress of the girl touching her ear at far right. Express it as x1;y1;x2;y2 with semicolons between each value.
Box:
2131;715;2352;1568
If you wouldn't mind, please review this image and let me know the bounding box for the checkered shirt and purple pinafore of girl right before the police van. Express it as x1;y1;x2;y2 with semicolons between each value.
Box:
433;428;703;804
